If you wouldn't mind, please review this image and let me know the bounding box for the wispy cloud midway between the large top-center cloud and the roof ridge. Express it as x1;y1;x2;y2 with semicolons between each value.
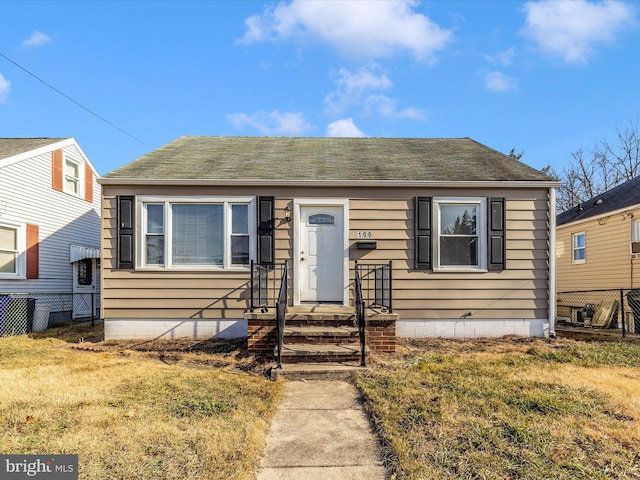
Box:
324;68;392;115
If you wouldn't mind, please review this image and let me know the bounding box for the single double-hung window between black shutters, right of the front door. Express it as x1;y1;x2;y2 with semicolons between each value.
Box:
433;198;487;270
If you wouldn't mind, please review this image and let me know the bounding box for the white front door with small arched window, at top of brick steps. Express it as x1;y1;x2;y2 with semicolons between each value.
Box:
299;205;344;303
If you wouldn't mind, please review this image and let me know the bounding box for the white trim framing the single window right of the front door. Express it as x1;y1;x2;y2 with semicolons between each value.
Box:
432;197;488;273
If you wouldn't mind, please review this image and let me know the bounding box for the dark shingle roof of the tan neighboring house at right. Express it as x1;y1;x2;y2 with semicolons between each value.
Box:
556;177;640;226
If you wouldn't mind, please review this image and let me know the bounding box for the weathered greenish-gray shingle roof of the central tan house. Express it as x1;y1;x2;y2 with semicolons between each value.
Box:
103;136;553;182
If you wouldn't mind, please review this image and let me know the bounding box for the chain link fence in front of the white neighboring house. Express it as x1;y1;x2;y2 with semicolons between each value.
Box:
0;293;100;337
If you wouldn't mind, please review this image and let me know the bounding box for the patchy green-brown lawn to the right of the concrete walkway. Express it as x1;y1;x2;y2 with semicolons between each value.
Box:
356;338;640;479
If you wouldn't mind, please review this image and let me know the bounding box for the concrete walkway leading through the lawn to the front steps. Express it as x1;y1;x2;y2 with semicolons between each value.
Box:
258;380;385;480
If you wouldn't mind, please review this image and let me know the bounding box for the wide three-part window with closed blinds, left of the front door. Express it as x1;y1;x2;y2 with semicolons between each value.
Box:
138;198;255;269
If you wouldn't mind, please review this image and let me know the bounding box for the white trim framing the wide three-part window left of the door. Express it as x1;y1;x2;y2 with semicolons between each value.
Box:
136;196;257;271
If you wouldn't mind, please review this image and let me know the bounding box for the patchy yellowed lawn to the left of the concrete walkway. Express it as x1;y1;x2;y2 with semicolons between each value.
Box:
0;331;282;480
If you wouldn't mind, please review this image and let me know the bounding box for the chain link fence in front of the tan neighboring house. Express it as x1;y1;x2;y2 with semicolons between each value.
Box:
556;288;640;336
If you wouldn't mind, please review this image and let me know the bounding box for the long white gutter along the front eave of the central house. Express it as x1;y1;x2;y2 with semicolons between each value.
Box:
98;177;560;188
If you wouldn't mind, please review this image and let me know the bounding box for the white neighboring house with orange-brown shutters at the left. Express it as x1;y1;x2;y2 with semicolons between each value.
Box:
0;138;101;335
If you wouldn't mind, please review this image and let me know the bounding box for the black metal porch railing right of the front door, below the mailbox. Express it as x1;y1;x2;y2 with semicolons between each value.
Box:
355;261;393;313
